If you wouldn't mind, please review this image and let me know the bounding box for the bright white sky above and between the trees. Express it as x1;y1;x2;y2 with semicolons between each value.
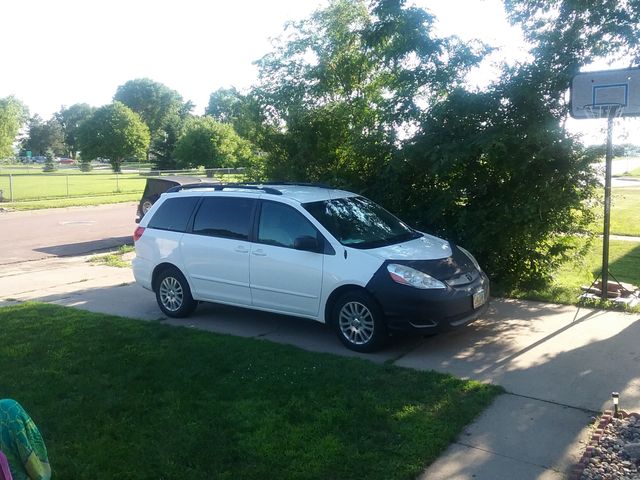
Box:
0;0;640;143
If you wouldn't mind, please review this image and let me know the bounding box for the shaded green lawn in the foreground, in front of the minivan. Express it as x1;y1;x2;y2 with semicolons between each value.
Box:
0;304;502;480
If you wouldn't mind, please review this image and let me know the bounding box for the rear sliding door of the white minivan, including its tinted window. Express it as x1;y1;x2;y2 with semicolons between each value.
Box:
182;196;256;305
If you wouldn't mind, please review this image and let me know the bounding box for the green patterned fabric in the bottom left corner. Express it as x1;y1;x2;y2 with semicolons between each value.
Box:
0;399;51;480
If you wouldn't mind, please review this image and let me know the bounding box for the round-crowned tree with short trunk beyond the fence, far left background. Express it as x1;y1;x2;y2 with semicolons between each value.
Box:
77;102;150;172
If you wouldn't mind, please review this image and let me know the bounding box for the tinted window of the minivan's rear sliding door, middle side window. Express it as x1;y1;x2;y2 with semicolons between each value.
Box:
193;197;255;240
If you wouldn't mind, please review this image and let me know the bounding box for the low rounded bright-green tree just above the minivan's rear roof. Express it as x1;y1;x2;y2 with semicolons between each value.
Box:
175;117;253;168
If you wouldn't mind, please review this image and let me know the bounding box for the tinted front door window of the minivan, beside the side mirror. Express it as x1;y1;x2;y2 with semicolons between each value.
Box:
258;202;318;248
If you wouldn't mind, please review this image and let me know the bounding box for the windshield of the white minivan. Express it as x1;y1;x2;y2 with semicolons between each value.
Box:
302;197;421;249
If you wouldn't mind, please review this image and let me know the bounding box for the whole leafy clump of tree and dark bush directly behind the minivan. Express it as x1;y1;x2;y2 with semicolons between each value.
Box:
245;0;595;289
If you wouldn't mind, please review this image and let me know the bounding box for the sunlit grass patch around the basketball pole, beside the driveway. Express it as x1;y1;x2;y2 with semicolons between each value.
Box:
497;239;640;311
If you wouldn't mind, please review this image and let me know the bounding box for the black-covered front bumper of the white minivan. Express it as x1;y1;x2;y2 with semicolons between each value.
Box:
367;267;490;334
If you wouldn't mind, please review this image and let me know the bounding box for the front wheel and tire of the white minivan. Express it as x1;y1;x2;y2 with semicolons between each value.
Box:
331;290;388;353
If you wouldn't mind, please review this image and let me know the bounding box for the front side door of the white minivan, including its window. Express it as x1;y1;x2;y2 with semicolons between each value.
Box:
250;200;324;317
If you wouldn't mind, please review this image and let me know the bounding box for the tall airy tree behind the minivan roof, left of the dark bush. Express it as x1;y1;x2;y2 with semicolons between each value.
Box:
252;0;484;189
